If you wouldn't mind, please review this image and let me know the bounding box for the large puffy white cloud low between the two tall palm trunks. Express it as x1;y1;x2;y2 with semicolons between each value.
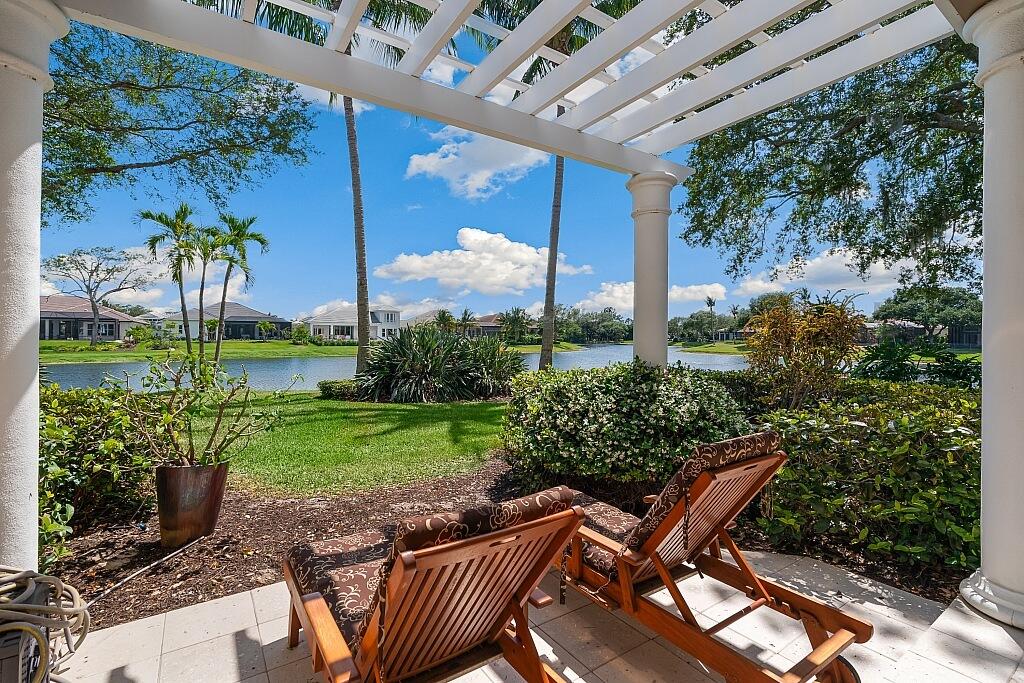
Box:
374;227;593;294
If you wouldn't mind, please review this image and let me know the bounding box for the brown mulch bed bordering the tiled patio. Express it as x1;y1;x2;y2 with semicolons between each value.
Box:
53;459;964;629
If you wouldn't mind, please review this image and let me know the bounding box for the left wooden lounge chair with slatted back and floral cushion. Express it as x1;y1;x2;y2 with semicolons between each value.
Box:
285;486;584;683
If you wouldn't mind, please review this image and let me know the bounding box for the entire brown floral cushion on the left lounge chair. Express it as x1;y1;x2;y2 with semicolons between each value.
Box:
288;486;572;652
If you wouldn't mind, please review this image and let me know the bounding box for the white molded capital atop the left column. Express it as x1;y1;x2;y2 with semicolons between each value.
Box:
0;0;70;90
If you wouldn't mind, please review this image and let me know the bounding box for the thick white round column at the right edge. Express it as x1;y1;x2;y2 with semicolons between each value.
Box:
961;0;1024;627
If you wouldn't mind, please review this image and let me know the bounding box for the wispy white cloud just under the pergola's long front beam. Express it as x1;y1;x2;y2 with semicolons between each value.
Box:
406;126;550;200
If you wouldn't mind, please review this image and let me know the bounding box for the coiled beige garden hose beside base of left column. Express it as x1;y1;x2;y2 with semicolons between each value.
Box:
0;565;89;683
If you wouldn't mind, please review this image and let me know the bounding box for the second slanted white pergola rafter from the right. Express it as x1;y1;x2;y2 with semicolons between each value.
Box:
598;0;921;142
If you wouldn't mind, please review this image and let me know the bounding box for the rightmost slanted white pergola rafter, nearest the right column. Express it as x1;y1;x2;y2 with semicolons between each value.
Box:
634;3;953;154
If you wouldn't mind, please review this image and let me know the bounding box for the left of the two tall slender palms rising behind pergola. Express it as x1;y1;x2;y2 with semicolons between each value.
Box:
207;0;432;373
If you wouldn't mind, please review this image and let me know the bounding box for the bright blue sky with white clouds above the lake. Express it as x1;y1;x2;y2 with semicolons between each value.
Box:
42;36;894;325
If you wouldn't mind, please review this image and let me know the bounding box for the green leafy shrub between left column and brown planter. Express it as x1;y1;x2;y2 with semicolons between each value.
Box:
39;385;169;567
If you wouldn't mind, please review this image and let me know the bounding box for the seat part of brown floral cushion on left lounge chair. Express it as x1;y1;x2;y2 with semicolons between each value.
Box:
288;526;396;652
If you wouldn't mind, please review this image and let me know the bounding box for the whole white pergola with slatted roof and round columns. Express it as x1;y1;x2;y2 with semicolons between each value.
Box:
0;0;1024;626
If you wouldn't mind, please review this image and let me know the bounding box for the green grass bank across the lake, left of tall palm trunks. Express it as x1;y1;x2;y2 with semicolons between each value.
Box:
39;339;355;364
